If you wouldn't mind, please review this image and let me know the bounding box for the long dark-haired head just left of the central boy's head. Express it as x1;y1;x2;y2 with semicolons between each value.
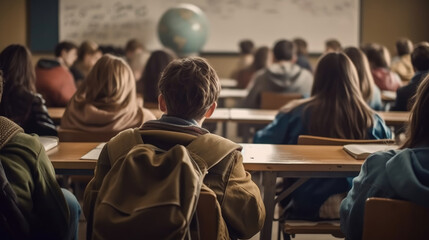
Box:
139;50;176;103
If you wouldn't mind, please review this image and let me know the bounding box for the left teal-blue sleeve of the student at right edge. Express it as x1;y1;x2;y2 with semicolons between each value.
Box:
340;153;394;240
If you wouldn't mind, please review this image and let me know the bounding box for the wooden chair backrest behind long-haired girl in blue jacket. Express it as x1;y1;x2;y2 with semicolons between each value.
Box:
298;135;395;146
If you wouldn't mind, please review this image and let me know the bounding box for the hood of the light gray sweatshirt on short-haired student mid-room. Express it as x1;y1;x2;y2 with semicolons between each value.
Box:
265;62;303;88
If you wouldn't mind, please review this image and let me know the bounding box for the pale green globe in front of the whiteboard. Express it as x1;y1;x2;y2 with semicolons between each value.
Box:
158;4;209;57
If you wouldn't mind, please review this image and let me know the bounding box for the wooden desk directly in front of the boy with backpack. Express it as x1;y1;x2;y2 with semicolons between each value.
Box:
47;142;363;239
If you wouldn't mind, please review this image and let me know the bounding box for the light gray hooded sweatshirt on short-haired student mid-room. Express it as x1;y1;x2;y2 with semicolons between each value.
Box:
241;62;313;108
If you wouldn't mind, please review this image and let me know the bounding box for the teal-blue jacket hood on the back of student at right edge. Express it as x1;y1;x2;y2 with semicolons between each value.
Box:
386;148;429;206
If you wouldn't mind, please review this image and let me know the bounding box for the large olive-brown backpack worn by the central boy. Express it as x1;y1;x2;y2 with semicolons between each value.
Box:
92;131;240;239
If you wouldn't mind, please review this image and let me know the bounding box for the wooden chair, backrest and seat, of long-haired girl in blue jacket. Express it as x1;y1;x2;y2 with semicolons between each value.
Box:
282;135;395;238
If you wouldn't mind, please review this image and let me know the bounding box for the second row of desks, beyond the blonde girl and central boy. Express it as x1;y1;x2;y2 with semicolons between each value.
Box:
48;108;410;126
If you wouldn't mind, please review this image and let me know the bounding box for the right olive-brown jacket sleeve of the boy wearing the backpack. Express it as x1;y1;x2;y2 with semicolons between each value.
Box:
220;151;265;239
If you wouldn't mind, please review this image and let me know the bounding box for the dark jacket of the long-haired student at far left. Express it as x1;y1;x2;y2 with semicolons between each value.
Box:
0;89;57;136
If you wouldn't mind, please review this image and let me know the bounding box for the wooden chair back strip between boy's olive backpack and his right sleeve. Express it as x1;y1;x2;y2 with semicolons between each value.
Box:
197;190;218;240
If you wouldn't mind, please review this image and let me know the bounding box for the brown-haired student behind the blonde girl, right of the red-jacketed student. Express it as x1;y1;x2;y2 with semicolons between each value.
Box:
70;41;102;86
